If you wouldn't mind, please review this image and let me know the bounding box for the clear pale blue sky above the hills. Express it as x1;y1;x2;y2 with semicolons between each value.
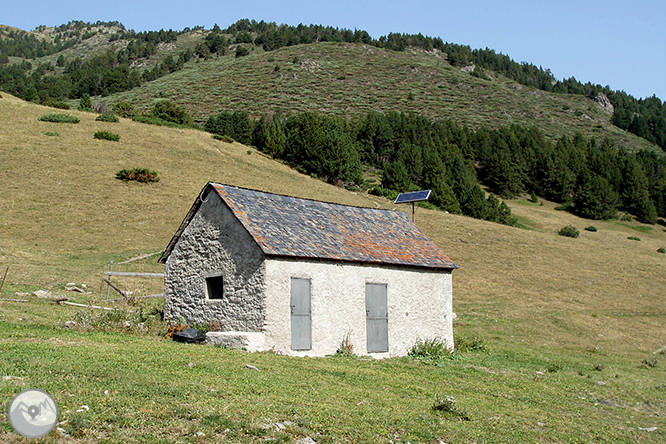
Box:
5;0;666;100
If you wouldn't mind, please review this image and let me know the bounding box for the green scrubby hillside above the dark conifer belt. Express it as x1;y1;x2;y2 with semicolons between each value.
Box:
2;27;661;152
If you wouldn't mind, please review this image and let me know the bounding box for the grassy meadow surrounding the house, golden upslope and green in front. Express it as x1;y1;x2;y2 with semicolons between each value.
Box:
0;93;666;444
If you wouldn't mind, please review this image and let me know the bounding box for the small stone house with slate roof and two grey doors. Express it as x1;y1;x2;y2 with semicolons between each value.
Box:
159;183;458;357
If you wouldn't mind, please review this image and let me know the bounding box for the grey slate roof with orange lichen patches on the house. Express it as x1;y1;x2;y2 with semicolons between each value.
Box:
160;183;458;269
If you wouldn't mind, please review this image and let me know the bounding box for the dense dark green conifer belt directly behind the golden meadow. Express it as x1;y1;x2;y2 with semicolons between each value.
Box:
204;111;666;224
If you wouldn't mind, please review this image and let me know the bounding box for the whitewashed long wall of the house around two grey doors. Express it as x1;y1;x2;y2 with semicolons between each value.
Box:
264;258;453;357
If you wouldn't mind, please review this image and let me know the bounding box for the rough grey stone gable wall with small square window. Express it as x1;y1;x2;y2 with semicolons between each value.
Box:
164;192;265;332
